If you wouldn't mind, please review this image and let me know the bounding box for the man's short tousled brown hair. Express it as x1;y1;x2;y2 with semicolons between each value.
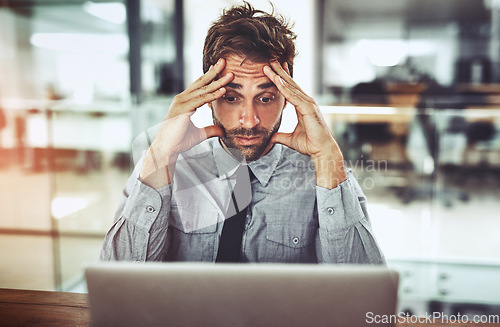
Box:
203;1;297;76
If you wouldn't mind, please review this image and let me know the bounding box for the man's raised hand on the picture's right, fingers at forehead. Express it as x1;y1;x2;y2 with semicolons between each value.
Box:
264;61;347;189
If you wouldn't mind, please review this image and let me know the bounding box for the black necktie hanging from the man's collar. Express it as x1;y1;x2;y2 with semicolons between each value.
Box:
215;165;253;262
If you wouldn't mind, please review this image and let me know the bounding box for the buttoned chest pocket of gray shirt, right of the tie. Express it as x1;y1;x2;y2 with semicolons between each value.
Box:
265;222;319;263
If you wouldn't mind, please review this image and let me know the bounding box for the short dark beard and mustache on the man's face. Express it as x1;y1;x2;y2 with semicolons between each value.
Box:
212;112;281;162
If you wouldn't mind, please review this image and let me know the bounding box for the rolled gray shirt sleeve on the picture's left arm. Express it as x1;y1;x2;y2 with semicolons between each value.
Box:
100;158;172;262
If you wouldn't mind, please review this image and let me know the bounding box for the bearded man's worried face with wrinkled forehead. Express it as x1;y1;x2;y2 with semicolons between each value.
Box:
209;55;285;161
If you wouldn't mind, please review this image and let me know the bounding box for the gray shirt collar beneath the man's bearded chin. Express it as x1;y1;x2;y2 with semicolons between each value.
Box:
212;138;283;186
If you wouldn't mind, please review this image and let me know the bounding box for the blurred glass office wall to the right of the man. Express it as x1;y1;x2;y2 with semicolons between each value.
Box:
318;0;500;315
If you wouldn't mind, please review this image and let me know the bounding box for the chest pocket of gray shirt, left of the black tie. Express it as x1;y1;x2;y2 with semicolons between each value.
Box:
166;205;219;262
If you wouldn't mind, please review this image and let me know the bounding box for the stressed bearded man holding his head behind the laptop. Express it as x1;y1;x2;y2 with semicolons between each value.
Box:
101;3;384;264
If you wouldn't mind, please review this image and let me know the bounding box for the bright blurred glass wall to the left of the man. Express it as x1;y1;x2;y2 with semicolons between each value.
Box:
0;0;175;291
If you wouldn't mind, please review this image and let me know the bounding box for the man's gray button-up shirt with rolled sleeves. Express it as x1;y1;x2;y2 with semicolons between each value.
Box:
101;138;384;264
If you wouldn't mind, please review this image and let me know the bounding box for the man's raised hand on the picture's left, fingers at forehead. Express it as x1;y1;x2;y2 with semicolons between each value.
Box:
140;58;234;189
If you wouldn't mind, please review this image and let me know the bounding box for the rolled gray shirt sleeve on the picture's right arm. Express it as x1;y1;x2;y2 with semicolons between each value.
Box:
316;171;385;264
